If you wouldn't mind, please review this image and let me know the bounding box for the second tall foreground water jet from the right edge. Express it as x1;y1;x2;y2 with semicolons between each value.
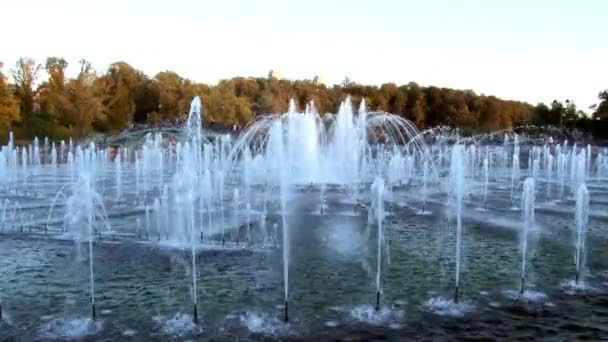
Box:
519;177;535;294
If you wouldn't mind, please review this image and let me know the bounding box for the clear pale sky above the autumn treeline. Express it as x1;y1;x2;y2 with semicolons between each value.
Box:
0;0;608;110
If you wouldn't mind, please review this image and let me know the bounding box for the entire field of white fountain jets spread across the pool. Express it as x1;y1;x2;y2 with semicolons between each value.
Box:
0;97;608;340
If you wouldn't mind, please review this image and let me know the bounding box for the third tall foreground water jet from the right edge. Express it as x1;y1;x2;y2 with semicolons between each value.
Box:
448;144;465;303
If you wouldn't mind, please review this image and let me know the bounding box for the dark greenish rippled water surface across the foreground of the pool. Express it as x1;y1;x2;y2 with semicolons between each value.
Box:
0;176;608;340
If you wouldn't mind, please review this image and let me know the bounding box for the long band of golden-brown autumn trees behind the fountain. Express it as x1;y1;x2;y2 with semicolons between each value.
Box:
0;57;608;139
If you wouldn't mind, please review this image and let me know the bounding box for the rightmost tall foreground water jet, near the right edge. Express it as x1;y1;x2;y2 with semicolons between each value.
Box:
575;183;589;285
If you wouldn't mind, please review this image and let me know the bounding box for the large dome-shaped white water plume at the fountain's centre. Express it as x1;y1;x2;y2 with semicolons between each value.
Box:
225;98;437;187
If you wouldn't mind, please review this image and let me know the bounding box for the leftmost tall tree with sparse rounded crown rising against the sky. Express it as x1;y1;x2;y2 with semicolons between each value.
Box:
12;57;41;120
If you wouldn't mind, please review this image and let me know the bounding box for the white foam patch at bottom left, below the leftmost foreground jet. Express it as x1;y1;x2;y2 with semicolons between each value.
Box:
40;317;103;339
